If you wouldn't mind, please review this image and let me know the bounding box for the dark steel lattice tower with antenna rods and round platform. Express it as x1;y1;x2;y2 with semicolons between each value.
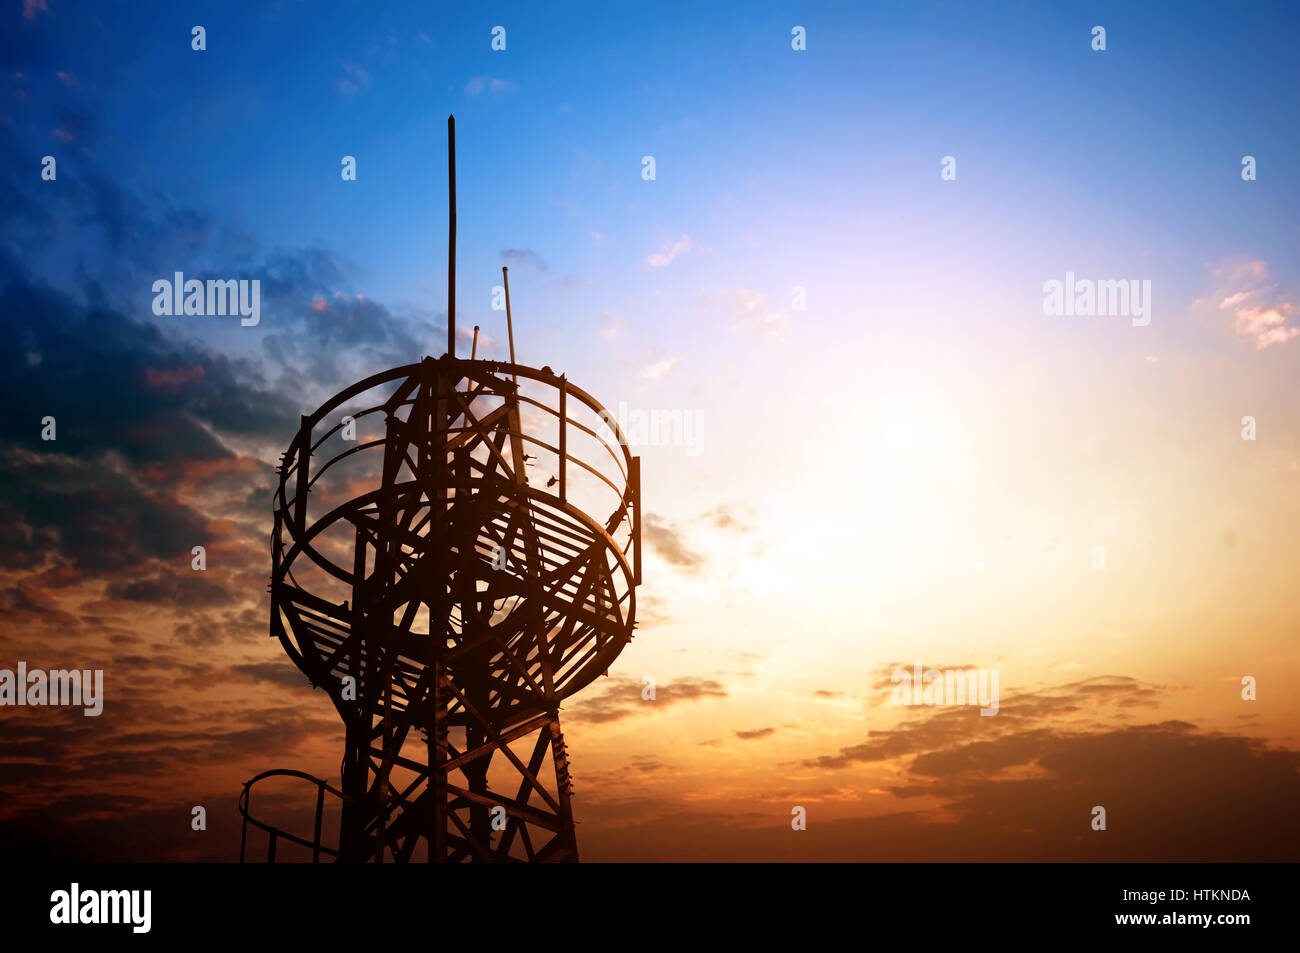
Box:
239;117;641;862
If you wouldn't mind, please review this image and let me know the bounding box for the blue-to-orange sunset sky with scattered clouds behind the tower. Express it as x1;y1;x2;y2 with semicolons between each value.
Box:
0;0;1300;861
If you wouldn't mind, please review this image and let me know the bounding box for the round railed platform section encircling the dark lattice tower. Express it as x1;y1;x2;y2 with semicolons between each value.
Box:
272;358;641;724
